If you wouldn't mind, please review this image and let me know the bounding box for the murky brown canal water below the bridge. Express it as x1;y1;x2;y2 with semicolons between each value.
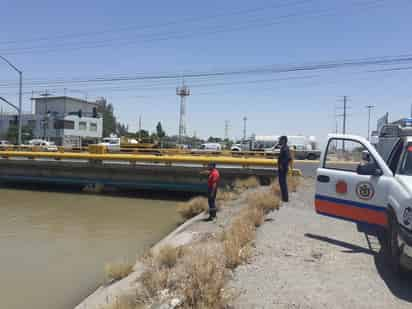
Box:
0;188;179;309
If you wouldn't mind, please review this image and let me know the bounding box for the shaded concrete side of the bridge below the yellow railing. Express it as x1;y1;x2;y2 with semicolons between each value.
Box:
0;159;275;193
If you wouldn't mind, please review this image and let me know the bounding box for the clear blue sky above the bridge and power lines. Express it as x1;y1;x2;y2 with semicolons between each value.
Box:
0;0;412;140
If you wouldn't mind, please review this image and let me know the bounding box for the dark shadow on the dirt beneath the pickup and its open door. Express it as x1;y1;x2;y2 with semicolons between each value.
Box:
305;233;412;303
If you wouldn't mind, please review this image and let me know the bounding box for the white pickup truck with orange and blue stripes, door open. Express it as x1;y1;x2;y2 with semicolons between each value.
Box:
315;134;412;273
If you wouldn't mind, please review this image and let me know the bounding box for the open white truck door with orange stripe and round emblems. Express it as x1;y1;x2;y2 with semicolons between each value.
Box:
315;135;393;227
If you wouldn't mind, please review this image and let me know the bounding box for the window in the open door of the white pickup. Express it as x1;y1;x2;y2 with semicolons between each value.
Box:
323;139;374;172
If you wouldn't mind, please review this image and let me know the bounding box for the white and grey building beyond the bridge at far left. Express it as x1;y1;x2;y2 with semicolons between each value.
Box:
0;96;103;146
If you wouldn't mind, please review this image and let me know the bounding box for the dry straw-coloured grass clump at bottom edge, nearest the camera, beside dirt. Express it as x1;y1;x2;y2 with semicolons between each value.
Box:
183;248;226;309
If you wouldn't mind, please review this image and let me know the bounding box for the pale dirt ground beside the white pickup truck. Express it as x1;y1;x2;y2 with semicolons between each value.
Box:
231;178;412;309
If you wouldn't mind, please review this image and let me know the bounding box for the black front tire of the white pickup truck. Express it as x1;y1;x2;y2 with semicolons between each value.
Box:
386;211;404;275
